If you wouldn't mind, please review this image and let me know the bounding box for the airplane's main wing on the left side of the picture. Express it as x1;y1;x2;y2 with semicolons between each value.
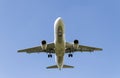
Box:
18;43;55;53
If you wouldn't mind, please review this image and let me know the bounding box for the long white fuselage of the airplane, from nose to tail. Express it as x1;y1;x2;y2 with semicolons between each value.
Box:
54;17;66;69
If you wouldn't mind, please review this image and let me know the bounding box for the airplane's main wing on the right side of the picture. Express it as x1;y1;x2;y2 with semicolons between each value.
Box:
66;42;102;53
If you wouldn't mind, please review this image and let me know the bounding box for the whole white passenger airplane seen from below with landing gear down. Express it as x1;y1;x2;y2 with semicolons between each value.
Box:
18;17;102;70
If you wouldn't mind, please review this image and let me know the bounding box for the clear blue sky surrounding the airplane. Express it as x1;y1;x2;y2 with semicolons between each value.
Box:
0;0;120;78
